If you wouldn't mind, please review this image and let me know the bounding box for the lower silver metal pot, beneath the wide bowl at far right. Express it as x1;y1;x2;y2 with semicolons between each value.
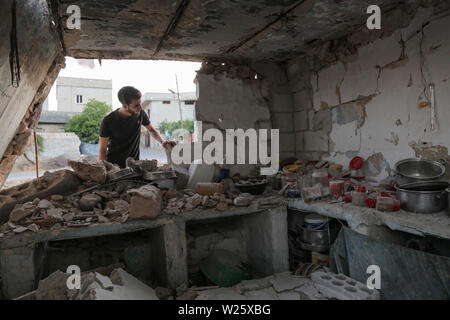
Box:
397;181;449;213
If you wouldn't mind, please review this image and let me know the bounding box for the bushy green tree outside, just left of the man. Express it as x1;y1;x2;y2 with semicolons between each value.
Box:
64;99;112;143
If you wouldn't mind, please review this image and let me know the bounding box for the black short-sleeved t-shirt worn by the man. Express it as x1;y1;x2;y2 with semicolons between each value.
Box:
100;109;150;168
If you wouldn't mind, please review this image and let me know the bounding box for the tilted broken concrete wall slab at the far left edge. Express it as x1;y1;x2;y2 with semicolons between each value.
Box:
0;0;64;187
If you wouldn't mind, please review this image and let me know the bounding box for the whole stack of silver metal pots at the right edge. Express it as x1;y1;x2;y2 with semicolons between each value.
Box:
395;158;450;213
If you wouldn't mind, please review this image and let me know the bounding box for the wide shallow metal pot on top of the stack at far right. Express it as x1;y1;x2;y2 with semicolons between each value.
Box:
394;158;445;185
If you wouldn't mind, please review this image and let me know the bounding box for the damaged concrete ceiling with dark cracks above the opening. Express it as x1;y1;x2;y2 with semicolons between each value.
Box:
53;0;408;61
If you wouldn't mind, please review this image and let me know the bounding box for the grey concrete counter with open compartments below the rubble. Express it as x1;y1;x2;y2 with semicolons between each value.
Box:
0;205;289;299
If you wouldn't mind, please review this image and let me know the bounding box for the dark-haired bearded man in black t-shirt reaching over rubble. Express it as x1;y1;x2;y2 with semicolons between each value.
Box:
98;86;175;168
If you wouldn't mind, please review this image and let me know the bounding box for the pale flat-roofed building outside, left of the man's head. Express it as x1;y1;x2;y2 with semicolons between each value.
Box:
56;77;112;113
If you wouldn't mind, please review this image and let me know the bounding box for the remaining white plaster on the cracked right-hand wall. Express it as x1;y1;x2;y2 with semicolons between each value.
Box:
311;9;450;167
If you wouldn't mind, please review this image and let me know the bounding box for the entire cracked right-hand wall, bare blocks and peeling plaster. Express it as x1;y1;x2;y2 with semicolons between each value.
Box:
288;1;450;180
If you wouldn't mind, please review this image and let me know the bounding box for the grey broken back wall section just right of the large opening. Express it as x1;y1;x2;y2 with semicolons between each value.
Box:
196;61;296;174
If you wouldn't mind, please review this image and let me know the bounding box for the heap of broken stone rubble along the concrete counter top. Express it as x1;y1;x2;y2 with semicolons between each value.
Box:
0;160;283;236
